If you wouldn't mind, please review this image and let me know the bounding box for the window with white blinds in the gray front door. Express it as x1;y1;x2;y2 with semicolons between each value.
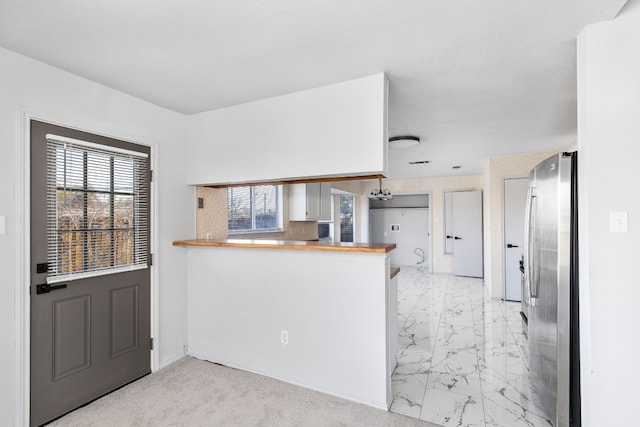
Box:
46;134;149;282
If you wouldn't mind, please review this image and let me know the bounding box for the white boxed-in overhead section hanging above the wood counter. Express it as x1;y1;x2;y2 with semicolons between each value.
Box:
187;74;388;185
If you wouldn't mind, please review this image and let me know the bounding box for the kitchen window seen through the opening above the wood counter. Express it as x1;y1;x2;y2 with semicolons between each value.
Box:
227;185;282;234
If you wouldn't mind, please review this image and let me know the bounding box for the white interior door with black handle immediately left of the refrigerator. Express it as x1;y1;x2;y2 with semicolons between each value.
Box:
503;178;529;301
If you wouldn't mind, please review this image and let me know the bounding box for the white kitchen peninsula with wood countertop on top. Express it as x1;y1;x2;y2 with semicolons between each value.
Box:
173;239;397;410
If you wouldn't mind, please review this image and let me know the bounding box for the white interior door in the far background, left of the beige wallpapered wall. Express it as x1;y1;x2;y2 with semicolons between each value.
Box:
452;191;483;277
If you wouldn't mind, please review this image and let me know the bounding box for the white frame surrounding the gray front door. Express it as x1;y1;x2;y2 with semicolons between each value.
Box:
13;106;159;425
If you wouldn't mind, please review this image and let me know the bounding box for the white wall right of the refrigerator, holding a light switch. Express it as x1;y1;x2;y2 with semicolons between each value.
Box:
578;0;640;427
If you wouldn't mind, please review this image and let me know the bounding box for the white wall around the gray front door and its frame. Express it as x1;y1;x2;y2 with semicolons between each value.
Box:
0;48;194;425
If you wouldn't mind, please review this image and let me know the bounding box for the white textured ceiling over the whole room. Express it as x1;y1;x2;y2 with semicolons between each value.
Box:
0;0;626;178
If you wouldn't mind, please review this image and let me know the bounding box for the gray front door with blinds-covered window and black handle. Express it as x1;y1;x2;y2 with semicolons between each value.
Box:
30;121;151;425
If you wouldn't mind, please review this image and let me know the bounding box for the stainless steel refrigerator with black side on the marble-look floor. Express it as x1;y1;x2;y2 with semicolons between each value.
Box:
523;152;581;427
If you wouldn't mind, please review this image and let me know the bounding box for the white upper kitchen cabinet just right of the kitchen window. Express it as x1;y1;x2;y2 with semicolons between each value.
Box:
289;182;331;221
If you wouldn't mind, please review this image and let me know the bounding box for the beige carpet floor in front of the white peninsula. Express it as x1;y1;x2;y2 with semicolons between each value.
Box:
50;357;435;427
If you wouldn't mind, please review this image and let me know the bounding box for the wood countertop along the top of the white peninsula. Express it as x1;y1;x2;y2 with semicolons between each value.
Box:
173;239;396;253
